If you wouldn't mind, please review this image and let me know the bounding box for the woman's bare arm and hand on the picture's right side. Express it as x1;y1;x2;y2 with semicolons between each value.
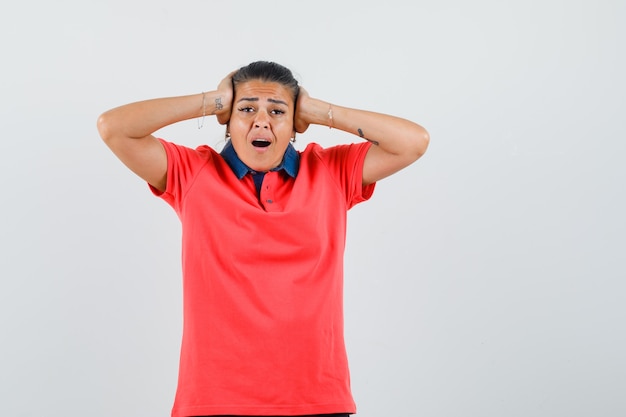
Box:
296;88;430;185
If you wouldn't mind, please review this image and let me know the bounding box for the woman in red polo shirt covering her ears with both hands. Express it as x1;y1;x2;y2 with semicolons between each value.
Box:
98;61;429;417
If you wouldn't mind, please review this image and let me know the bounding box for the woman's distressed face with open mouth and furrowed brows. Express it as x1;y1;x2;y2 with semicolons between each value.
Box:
229;80;295;172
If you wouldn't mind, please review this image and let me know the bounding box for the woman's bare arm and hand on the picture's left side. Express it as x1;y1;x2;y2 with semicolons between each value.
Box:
98;76;232;191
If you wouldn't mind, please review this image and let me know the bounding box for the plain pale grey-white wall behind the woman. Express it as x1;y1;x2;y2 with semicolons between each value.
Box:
0;0;626;417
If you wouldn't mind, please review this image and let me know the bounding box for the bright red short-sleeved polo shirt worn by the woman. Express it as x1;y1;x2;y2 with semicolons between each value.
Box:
153;141;374;417
